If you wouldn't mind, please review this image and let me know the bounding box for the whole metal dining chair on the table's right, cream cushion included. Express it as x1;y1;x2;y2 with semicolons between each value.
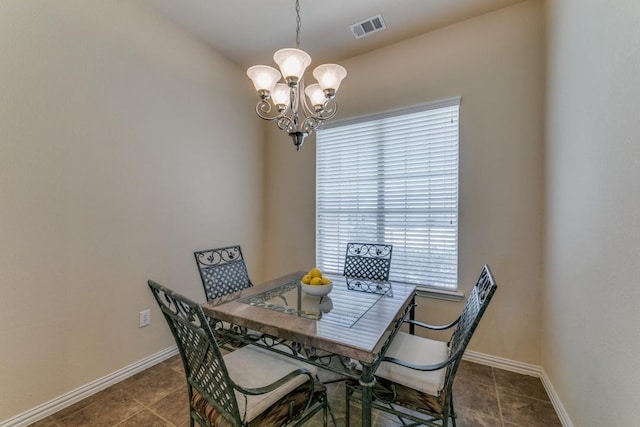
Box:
345;265;497;427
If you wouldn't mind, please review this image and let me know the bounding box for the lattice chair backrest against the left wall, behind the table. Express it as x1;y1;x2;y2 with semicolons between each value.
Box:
193;246;253;301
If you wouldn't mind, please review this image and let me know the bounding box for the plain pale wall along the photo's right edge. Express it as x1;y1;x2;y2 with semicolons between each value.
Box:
542;0;640;426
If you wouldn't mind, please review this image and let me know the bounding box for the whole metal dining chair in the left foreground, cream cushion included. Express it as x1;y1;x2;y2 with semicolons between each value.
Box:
148;280;335;426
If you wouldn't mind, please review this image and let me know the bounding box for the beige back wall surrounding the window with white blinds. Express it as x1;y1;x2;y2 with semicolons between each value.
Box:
265;1;544;365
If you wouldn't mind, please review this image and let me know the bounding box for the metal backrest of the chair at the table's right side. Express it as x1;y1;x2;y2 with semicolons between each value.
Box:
444;264;498;390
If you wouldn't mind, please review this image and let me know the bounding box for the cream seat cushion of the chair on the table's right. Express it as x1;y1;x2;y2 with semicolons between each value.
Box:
376;332;448;396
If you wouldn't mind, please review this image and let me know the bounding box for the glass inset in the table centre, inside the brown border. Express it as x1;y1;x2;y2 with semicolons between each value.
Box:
238;276;392;328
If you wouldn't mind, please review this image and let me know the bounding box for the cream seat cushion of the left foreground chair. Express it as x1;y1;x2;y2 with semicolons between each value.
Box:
224;345;318;422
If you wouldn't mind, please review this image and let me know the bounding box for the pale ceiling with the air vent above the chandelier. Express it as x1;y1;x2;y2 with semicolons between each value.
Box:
142;0;523;68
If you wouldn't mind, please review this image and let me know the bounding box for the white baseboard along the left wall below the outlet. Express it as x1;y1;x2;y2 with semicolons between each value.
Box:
0;345;178;427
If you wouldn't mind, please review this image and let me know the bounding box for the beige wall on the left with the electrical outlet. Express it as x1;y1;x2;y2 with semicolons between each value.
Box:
0;0;263;421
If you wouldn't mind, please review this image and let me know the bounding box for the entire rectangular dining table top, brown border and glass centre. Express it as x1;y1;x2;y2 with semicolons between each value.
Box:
202;271;415;363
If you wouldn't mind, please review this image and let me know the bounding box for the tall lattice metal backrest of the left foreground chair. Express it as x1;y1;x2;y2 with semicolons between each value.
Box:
148;280;241;425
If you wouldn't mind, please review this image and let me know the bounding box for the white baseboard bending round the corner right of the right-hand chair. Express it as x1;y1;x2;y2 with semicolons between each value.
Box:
463;350;573;427
